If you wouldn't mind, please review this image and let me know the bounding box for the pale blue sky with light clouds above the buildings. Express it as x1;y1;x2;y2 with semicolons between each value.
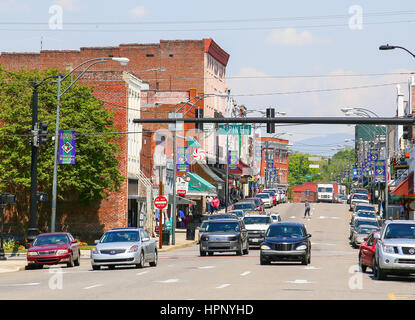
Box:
0;0;415;154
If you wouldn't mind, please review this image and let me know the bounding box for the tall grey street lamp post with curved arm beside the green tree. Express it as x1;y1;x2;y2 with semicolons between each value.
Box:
51;57;130;232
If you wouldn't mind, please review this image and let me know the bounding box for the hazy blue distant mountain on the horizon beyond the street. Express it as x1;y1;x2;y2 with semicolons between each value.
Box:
291;133;354;156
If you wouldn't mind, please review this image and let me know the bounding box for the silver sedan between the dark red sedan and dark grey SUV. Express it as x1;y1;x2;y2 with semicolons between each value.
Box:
91;228;158;270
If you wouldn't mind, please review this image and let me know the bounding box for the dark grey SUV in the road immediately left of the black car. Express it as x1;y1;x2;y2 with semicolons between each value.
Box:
199;219;249;256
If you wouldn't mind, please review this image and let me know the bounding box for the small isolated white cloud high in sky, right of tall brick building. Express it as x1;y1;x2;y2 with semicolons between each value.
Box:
266;28;316;46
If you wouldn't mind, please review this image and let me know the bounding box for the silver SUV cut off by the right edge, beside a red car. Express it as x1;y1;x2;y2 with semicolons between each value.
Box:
373;220;415;280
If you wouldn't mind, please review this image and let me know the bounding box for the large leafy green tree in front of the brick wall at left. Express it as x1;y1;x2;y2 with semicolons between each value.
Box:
0;69;124;203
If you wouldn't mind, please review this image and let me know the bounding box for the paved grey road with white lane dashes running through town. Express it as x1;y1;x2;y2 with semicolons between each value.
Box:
0;204;415;300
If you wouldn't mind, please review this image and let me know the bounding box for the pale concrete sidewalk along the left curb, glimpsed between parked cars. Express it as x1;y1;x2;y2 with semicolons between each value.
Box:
0;229;197;274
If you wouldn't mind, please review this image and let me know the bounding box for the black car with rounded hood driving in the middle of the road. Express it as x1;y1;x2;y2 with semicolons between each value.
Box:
260;222;311;265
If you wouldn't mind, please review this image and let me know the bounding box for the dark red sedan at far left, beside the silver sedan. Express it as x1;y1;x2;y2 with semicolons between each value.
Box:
26;232;81;269
